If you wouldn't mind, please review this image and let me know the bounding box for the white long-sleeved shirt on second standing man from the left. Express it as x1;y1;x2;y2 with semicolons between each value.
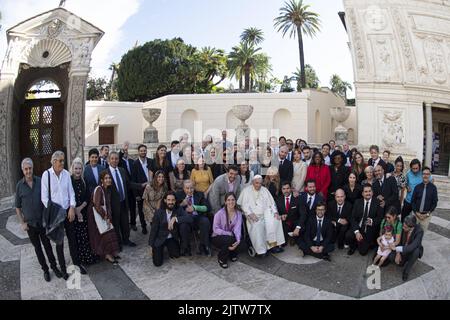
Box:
41;168;76;210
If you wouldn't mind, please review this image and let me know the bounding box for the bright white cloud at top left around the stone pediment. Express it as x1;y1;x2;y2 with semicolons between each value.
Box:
0;0;143;76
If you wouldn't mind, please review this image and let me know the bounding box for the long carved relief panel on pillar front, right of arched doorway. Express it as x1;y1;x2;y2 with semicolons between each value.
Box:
68;76;87;161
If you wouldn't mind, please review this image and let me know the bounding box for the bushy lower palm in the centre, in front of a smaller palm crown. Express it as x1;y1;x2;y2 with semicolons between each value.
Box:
228;42;261;92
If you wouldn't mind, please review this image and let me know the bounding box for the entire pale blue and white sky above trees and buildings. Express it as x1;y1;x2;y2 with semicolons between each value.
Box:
0;0;353;94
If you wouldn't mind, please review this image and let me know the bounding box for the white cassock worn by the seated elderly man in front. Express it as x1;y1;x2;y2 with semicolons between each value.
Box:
237;185;285;254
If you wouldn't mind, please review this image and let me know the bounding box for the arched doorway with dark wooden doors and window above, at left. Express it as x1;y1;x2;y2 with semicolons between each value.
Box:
19;80;64;176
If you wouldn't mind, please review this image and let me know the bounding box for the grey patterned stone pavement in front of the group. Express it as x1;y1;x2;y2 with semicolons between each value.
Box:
0;210;450;300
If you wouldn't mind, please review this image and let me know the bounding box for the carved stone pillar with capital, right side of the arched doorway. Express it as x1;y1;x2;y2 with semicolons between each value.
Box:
65;69;89;167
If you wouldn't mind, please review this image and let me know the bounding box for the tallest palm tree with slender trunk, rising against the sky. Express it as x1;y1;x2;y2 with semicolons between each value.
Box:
274;0;320;88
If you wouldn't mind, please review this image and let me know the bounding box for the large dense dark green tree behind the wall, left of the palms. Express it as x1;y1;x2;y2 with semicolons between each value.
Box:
117;38;227;101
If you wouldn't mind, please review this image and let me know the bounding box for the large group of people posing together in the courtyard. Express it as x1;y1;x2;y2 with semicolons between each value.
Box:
16;131;438;281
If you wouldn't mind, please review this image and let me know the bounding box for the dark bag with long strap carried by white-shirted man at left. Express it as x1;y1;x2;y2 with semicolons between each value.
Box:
42;170;67;244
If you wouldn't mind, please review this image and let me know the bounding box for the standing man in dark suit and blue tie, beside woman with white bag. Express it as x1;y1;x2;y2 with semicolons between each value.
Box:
106;152;139;247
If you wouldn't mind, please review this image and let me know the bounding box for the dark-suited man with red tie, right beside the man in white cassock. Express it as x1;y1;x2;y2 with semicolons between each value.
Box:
275;182;306;246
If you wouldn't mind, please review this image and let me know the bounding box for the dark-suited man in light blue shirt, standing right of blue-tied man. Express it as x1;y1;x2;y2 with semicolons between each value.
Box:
130;144;151;234
